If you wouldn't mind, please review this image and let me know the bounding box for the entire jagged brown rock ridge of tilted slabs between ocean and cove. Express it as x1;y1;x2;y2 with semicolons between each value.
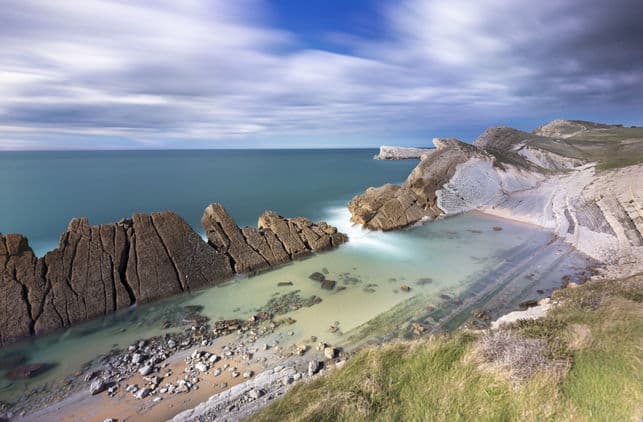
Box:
0;204;347;346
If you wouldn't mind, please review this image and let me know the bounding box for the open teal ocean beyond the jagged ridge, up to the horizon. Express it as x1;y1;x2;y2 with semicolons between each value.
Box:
0;149;417;256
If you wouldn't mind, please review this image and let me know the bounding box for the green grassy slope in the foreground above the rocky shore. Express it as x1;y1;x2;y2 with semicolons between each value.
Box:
253;276;643;421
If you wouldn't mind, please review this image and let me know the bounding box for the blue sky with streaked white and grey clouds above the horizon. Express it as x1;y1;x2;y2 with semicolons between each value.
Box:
0;0;643;150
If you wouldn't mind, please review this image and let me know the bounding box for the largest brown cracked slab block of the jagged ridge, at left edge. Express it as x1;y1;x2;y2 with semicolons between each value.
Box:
0;212;233;345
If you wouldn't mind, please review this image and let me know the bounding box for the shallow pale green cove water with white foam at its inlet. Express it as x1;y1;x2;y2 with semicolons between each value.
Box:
0;211;588;399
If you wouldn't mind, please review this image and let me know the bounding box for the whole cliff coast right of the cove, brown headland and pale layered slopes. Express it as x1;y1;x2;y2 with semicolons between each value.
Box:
348;120;643;272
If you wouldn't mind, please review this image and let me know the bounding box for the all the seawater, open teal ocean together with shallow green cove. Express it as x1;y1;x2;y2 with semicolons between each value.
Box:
0;149;585;400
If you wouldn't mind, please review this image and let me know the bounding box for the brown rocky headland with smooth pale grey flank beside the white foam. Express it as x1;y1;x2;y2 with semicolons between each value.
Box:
348;138;538;230
